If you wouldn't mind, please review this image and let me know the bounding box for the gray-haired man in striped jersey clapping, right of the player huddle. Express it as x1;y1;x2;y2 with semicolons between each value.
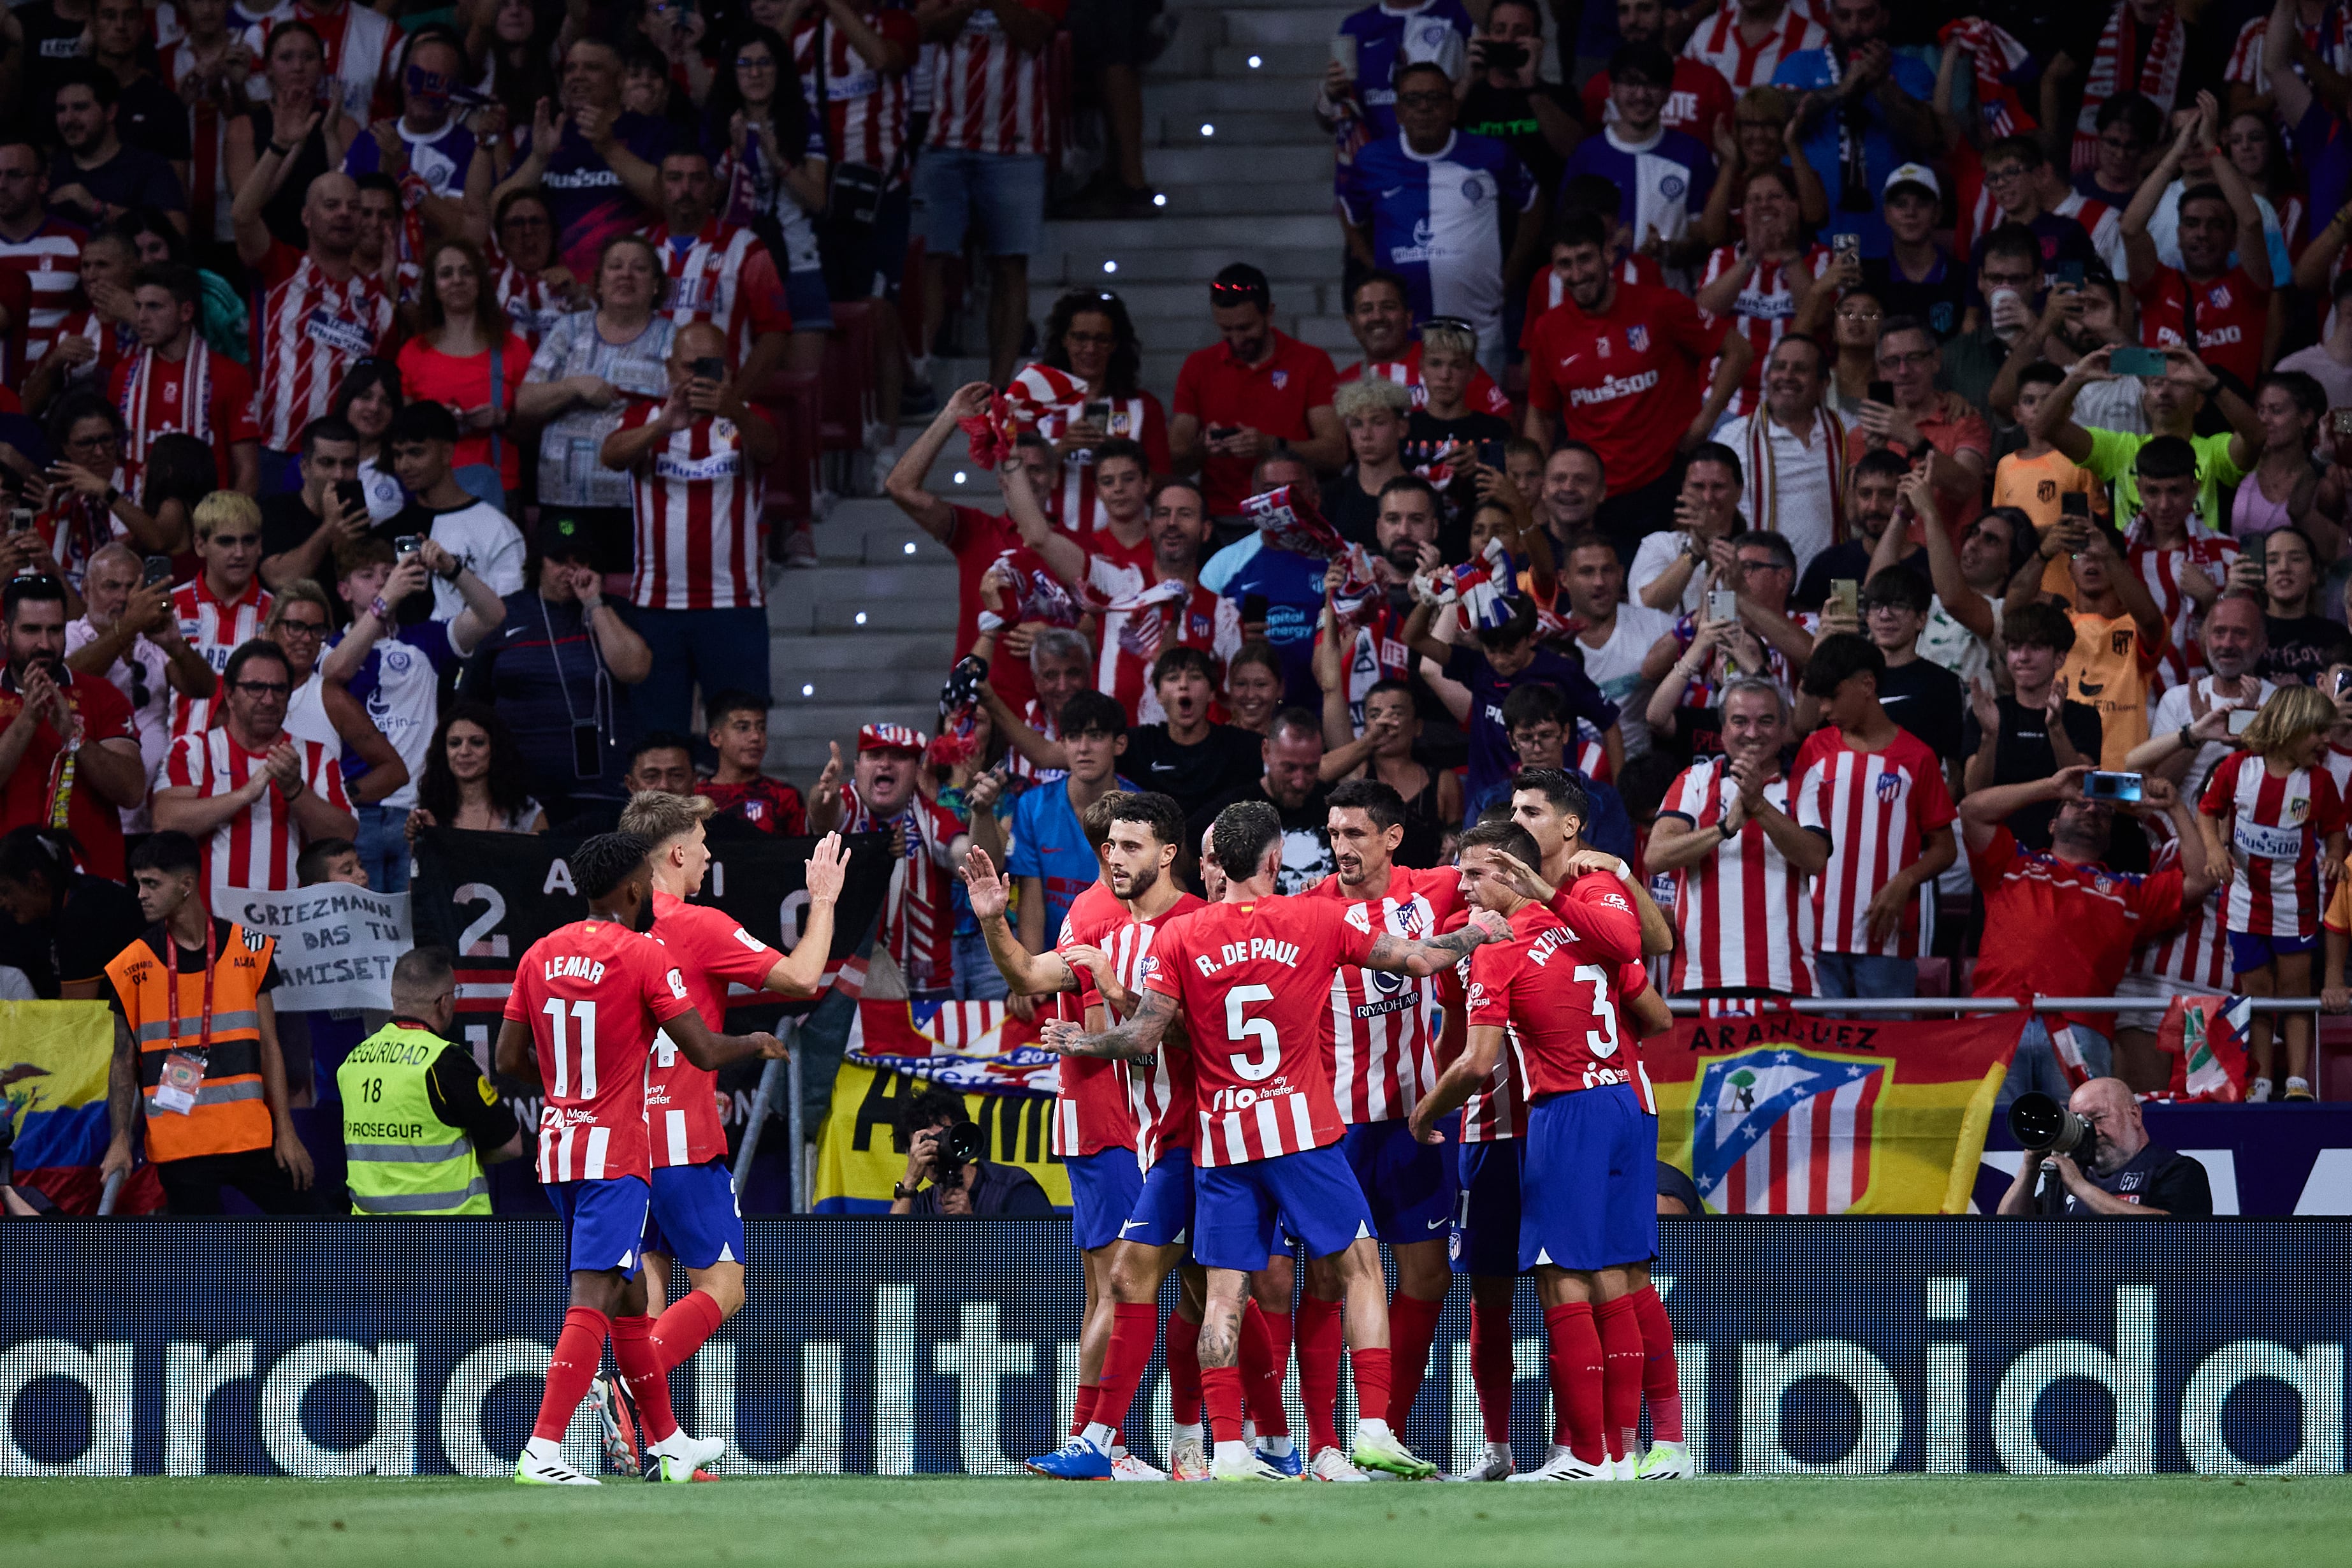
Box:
1649;675;1830;997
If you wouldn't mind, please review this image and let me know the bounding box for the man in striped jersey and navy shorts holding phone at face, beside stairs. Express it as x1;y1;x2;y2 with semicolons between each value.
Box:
602;322;776;747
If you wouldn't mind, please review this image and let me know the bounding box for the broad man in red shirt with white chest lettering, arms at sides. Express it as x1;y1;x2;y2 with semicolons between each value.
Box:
1527;212;1755;534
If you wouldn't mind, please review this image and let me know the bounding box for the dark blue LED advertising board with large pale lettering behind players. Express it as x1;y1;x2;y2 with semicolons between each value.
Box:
0;1217;2352;1476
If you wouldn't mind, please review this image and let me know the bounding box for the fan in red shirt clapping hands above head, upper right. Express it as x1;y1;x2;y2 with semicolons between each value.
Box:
2121;92;2281;388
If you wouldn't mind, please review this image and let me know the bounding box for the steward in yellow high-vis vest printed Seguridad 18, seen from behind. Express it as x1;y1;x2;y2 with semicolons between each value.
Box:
334;947;522;1217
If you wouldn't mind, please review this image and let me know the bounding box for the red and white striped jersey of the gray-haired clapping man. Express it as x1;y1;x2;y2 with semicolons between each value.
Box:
1658;757;1827;997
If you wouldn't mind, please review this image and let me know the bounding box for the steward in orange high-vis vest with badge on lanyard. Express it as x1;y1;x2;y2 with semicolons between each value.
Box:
99;832;317;1213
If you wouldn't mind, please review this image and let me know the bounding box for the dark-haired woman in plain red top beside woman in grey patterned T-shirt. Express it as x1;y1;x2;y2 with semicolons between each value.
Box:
400;240;532;510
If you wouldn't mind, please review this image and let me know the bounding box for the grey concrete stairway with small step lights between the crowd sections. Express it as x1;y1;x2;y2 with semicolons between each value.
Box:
767;0;1354;790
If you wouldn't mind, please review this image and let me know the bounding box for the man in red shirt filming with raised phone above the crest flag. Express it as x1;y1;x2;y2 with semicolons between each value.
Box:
1959;764;2223;1110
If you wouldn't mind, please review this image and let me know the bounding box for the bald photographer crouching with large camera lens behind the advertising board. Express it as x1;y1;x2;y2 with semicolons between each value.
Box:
2000;1079;2213;1220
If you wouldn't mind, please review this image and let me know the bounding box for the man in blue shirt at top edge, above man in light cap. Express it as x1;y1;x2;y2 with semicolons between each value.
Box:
1771;0;1943;256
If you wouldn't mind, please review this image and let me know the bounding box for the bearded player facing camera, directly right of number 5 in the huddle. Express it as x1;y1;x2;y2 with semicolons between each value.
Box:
1298;778;1465;1481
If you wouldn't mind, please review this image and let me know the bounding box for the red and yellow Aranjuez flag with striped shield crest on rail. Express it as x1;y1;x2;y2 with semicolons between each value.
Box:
1642;1013;2025;1213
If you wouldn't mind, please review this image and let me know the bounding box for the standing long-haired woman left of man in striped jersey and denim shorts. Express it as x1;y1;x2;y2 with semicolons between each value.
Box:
703;26;832;369
